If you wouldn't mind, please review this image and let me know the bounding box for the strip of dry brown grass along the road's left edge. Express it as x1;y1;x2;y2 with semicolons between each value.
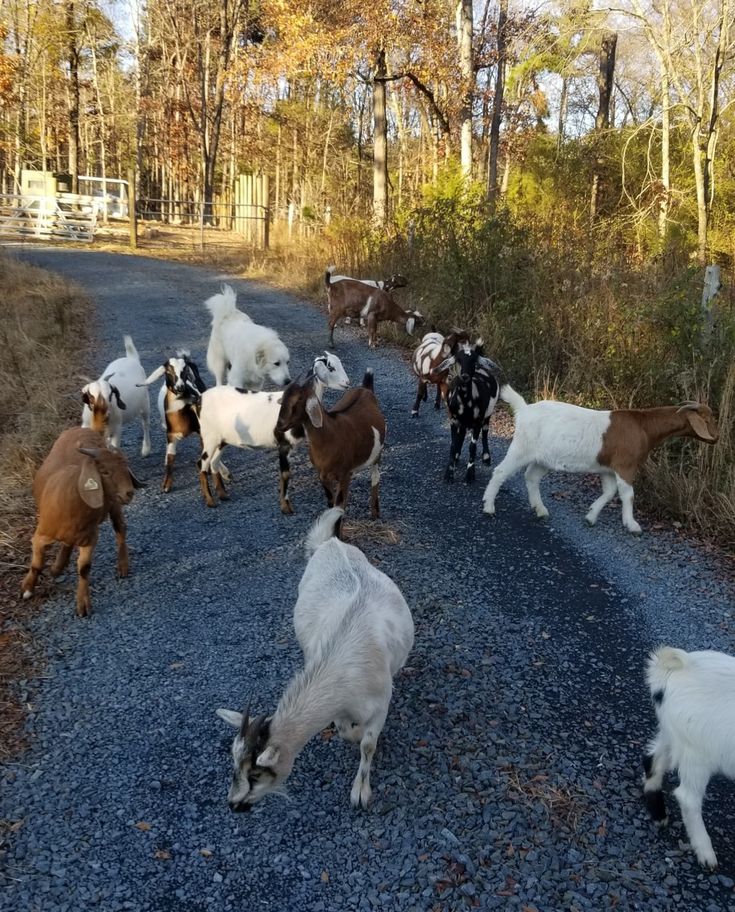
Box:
0;253;90;760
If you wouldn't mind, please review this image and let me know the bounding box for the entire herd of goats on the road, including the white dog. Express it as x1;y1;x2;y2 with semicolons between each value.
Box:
15;267;735;868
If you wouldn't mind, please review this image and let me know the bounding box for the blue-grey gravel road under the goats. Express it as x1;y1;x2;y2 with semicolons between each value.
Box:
0;249;735;912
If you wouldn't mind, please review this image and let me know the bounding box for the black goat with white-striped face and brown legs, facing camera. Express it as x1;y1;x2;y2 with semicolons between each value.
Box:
140;349;210;493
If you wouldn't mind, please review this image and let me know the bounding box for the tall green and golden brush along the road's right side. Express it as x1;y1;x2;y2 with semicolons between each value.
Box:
244;182;735;549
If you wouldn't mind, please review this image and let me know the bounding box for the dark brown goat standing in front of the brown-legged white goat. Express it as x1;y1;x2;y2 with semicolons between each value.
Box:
276;370;385;518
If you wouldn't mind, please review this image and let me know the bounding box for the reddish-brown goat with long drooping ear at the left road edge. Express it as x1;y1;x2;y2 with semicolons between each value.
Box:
21;428;142;617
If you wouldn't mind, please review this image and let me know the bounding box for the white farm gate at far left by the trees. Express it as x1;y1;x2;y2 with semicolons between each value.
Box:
0;193;97;241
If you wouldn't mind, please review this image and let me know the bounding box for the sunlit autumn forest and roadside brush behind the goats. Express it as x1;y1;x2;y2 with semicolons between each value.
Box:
0;0;735;547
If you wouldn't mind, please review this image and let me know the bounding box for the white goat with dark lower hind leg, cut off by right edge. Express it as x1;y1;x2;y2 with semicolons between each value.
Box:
643;646;735;869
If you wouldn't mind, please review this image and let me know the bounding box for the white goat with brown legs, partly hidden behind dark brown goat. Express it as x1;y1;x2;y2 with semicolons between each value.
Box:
199;352;350;513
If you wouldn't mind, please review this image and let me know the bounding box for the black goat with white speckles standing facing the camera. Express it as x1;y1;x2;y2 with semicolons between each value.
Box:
436;339;500;484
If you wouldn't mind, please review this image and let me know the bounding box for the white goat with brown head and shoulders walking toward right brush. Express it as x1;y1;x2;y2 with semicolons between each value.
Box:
483;384;719;535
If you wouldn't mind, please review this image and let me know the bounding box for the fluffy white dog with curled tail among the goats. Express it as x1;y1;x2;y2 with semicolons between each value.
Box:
204;285;291;390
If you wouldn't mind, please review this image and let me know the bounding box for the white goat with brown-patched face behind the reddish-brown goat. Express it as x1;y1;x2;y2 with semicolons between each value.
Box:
82;336;151;456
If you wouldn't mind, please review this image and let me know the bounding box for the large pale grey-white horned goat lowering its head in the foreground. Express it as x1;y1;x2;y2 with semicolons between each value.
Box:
217;507;413;811
